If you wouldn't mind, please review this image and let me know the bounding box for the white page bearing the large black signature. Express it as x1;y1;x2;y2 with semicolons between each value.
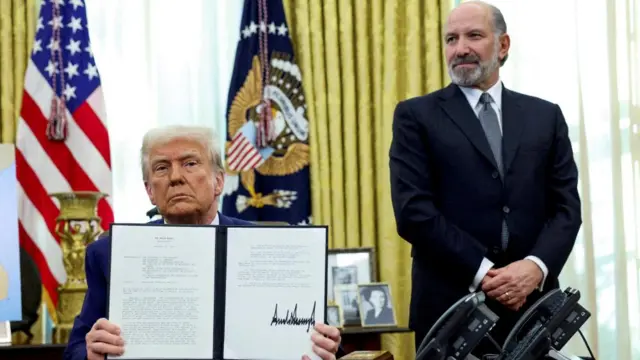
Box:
224;227;327;360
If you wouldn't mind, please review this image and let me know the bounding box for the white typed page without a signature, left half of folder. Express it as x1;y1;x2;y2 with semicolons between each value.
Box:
109;225;216;359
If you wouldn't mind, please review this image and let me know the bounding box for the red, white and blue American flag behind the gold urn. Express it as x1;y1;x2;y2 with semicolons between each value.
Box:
16;0;113;311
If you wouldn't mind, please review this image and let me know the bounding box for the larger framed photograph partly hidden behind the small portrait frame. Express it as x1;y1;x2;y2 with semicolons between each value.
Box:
327;247;378;302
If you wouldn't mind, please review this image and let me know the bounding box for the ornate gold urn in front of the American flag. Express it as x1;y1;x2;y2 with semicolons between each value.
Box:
49;191;107;344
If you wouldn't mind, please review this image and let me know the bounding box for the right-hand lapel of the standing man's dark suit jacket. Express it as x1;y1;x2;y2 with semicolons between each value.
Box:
502;87;527;174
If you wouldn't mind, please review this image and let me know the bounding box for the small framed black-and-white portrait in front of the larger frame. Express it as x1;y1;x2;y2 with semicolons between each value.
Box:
358;283;398;327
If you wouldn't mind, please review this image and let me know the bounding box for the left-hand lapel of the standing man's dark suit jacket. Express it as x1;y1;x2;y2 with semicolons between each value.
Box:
441;84;498;169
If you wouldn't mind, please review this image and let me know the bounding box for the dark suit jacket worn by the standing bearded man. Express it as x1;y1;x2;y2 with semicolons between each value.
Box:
390;85;582;343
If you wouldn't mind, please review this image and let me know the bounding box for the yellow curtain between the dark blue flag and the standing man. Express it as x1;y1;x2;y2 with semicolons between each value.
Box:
285;0;450;359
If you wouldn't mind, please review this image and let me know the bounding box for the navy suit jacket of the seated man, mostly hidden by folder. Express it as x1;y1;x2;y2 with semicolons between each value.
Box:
64;213;253;360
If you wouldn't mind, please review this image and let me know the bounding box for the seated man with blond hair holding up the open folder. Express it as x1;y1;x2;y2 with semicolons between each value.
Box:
64;126;341;360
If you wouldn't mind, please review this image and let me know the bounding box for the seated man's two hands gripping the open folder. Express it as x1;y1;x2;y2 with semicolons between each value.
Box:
85;319;342;360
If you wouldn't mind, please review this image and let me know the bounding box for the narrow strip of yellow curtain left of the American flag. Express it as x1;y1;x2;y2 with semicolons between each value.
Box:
0;0;36;143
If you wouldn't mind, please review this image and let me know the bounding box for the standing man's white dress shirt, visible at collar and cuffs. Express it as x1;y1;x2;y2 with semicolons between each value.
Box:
460;80;549;292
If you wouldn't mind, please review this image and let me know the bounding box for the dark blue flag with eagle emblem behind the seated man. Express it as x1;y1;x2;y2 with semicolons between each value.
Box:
222;0;311;225
